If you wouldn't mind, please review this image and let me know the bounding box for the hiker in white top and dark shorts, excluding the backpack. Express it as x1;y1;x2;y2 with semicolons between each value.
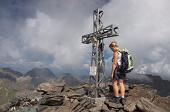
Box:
109;41;126;103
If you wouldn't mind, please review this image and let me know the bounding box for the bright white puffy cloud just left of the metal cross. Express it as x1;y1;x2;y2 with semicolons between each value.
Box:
18;12;87;68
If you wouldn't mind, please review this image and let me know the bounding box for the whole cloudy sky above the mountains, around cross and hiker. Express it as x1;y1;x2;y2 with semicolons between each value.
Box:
0;0;170;79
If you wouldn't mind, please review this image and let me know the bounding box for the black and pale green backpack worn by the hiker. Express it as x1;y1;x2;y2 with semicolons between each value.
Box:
119;48;134;73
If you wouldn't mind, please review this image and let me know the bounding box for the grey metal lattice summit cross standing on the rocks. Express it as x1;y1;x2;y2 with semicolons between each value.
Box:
82;9;119;98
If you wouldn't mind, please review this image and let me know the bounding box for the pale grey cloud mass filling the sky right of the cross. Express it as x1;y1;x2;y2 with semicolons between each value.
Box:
103;0;170;77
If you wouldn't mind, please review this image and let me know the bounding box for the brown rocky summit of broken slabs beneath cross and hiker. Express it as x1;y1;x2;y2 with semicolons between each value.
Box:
0;82;170;112
